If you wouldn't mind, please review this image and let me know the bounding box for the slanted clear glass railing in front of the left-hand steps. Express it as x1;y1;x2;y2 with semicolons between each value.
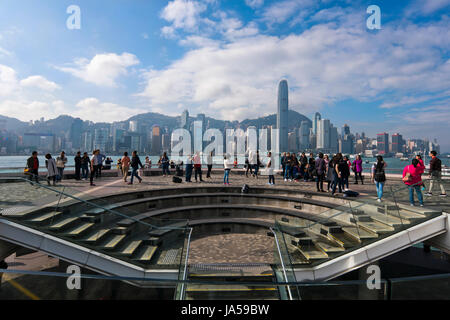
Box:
0;178;192;270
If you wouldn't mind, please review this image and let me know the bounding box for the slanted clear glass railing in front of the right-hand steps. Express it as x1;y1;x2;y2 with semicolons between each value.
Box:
275;180;448;268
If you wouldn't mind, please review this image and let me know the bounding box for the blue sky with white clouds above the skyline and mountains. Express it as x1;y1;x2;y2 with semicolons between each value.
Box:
0;0;450;151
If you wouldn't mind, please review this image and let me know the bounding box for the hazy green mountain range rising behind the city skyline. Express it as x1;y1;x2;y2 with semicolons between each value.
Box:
0;110;311;135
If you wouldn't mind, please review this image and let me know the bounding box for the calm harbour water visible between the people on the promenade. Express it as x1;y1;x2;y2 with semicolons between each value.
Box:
0;155;450;173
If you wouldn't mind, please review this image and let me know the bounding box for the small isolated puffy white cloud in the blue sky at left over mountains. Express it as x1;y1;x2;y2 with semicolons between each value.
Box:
56;52;140;87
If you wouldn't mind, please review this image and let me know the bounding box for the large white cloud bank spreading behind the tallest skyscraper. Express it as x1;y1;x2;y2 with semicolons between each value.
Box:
140;13;450;120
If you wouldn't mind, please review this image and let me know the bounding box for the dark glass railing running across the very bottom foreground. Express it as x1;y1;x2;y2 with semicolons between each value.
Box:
0;269;450;300
